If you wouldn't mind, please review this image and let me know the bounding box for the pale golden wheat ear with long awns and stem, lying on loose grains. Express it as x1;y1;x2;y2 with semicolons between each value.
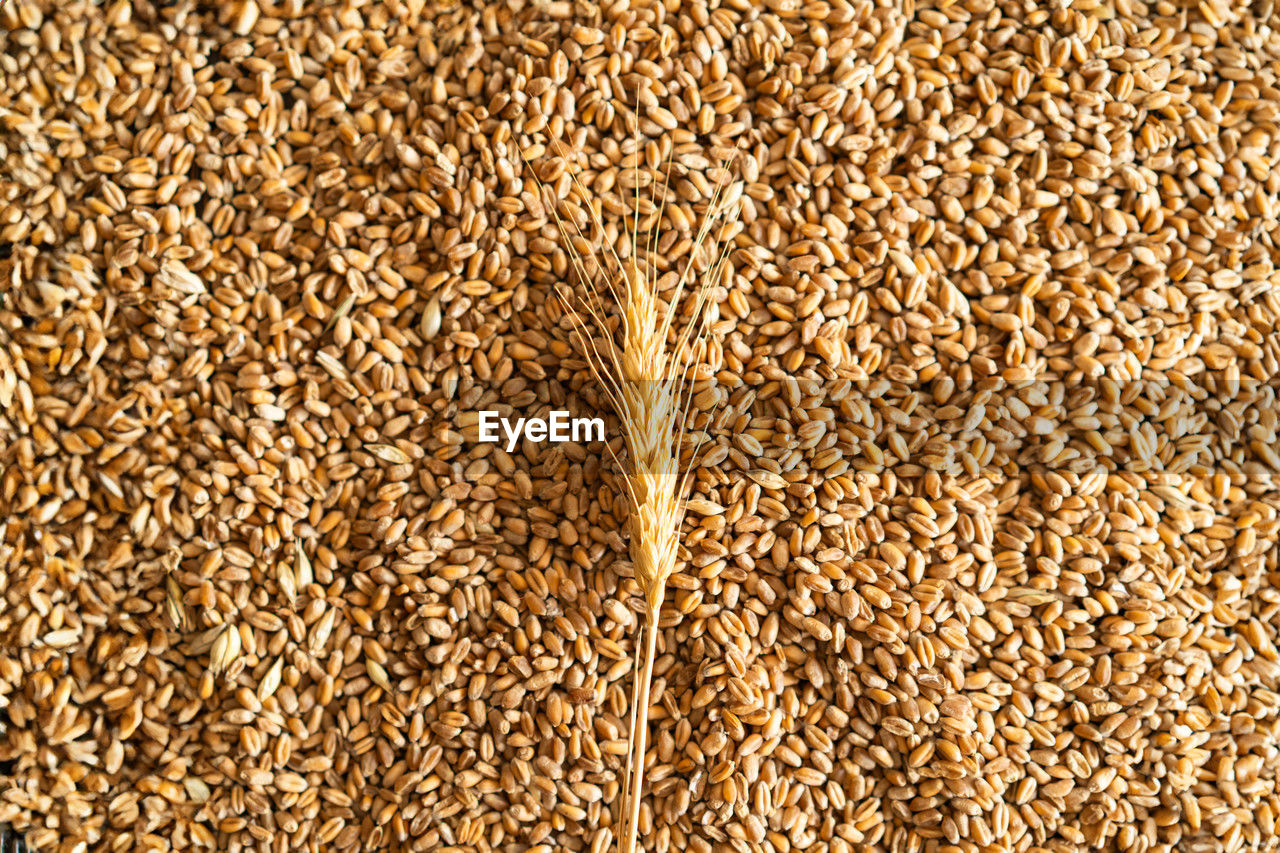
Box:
530;137;736;853
